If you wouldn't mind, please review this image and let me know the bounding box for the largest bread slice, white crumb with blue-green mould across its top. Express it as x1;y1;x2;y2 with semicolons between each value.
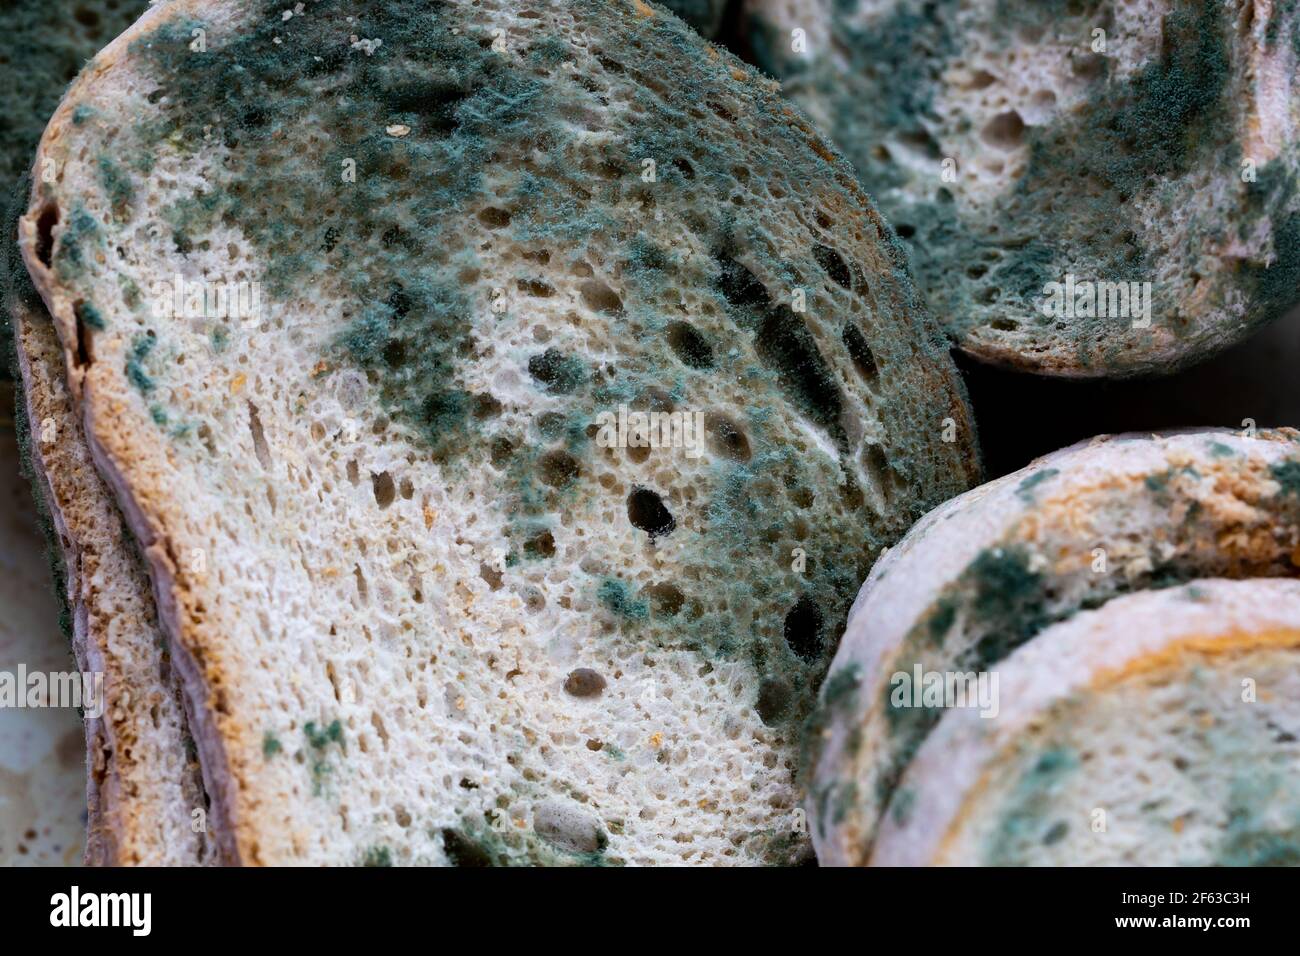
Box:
21;0;978;864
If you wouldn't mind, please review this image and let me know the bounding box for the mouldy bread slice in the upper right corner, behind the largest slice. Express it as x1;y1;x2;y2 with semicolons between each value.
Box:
748;0;1300;376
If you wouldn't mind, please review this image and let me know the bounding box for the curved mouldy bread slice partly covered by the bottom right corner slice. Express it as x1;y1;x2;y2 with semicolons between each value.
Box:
809;429;1300;865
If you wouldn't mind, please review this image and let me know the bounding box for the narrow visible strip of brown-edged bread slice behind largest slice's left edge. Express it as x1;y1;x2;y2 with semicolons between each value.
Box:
5;221;216;866
